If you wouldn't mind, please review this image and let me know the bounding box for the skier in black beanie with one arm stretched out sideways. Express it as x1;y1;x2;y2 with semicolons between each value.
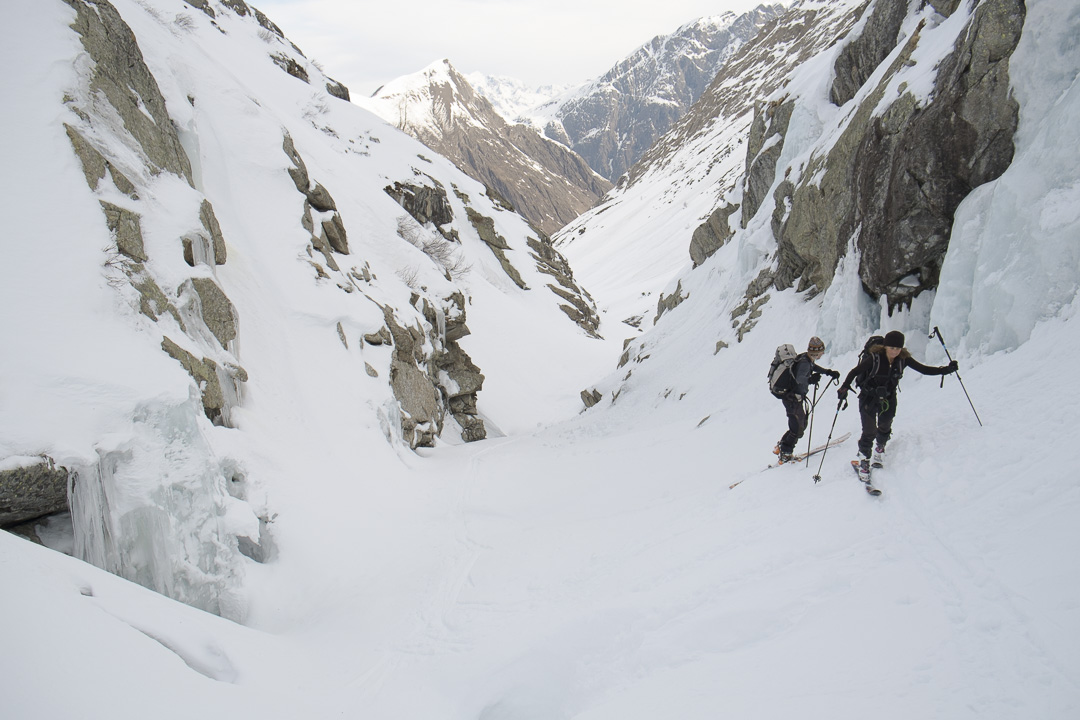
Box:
837;330;957;481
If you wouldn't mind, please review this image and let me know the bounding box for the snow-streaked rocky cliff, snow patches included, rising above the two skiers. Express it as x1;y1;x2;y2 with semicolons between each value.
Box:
626;0;1024;321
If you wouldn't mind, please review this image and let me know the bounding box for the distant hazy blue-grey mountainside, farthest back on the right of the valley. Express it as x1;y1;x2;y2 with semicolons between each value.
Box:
544;4;783;181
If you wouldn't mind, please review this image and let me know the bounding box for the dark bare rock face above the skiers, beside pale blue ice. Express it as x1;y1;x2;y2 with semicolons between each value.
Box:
774;0;1025;311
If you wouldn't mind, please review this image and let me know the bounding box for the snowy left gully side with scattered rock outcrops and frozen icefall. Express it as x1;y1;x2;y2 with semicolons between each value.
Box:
0;0;618;617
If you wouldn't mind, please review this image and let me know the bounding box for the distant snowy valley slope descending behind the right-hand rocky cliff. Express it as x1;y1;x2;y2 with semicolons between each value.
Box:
554;0;865;335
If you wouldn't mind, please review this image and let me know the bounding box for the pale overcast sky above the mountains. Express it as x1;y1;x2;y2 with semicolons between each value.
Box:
253;0;789;96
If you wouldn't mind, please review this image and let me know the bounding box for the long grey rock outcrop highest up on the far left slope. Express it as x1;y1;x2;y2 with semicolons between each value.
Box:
64;0;191;185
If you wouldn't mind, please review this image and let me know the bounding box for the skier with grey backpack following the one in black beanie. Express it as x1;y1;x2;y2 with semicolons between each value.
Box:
769;337;840;464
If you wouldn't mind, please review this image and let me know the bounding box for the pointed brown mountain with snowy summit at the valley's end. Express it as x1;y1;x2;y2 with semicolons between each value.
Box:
357;59;610;233
